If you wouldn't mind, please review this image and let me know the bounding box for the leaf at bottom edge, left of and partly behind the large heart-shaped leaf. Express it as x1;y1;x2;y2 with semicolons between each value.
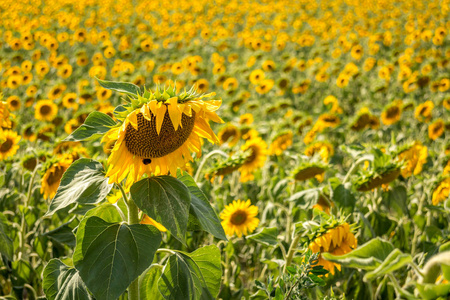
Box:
43;259;92;300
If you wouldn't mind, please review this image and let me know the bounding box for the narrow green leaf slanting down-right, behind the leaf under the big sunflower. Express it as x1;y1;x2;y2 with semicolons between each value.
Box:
177;171;227;241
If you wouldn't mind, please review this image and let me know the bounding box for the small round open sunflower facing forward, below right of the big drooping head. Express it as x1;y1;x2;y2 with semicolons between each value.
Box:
220;200;259;237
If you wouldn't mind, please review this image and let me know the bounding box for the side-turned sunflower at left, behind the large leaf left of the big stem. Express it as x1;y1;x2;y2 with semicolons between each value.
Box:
41;155;72;199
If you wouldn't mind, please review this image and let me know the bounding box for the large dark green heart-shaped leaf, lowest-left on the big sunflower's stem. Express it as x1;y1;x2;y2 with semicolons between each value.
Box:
73;217;161;300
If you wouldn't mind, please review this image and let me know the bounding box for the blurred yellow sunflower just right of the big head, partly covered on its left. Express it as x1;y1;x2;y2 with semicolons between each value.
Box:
239;137;267;182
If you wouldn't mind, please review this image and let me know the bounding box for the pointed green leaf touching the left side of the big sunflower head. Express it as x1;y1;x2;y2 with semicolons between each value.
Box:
64;111;116;142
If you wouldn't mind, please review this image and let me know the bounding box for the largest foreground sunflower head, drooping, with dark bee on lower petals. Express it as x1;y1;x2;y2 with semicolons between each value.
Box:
102;87;223;188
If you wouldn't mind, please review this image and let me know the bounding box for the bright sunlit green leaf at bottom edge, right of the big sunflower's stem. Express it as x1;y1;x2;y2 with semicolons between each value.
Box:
158;246;222;300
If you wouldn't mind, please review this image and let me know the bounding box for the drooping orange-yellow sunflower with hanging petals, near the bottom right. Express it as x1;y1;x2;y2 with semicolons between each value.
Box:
308;223;358;275
